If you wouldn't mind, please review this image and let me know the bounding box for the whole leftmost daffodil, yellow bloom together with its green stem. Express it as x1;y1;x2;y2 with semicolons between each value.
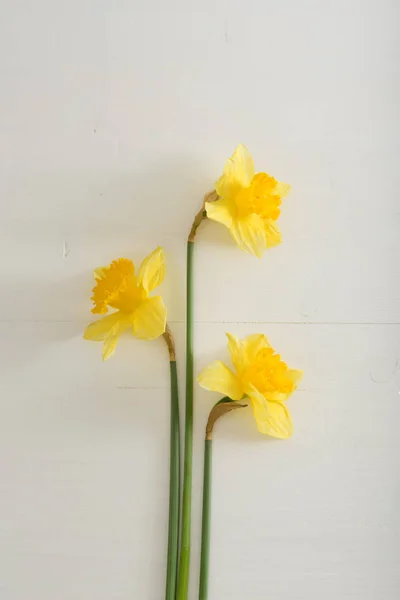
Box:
84;247;180;600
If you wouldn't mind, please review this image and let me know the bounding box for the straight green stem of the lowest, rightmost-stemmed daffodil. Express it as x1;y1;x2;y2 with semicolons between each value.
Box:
199;439;212;600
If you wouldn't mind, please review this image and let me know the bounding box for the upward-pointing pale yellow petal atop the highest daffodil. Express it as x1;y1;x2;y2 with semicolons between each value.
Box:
215;144;254;198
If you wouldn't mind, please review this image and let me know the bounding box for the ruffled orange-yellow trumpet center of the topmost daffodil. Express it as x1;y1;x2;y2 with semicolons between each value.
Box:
236;173;281;220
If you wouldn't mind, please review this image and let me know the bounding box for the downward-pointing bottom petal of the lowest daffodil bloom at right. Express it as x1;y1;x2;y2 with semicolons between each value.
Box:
247;388;293;439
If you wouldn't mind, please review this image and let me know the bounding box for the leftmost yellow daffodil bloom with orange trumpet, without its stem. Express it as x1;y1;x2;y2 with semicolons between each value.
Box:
84;247;167;360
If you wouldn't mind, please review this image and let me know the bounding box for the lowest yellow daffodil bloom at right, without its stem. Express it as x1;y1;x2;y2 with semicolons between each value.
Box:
198;333;303;438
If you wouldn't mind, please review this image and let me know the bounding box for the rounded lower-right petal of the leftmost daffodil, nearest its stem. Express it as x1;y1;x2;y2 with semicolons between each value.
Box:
133;296;167;340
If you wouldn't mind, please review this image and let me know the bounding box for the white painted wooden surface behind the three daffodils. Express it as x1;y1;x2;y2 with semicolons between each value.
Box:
0;0;400;600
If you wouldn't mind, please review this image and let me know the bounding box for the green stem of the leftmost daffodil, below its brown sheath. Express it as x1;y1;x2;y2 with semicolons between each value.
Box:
165;359;181;600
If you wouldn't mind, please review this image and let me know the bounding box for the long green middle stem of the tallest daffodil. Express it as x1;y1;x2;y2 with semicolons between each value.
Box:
176;241;194;600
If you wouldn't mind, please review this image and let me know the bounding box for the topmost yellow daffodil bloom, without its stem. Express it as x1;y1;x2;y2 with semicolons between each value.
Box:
205;144;290;258
